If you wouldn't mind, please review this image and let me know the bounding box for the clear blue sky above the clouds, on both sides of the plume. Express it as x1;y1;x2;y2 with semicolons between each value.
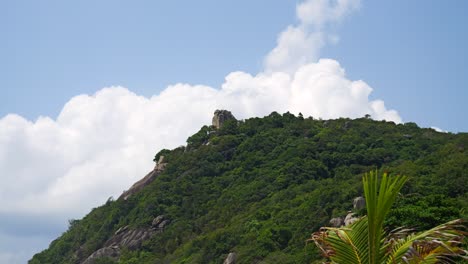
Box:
0;0;468;132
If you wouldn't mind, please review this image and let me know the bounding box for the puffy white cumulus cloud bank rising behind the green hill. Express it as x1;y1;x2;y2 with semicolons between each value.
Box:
0;0;401;262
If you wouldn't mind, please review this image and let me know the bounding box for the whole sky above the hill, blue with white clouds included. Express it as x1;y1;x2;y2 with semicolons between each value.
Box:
0;0;468;263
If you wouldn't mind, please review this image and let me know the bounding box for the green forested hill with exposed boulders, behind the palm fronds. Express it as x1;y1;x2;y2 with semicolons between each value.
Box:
29;111;468;264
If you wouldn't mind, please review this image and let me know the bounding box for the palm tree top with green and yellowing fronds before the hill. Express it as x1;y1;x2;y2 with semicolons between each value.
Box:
310;172;468;264
